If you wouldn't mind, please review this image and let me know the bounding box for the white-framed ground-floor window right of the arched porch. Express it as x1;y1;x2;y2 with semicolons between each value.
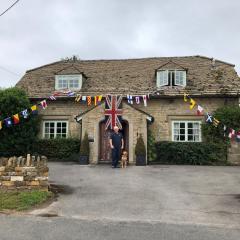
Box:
172;120;202;142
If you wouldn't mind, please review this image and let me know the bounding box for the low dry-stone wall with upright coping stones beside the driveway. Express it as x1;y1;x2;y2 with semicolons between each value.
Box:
0;154;49;191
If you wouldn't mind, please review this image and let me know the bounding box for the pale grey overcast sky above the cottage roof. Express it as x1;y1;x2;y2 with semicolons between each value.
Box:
0;0;240;87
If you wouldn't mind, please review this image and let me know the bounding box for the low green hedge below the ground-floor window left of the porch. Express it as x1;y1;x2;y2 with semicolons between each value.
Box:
34;138;80;161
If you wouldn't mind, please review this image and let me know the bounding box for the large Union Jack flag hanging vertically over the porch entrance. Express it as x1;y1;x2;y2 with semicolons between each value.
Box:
105;96;122;129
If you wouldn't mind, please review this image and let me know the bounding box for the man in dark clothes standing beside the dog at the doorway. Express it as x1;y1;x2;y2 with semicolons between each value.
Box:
110;126;124;168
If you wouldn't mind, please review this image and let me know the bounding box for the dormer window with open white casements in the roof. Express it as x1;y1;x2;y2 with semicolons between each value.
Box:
157;70;186;87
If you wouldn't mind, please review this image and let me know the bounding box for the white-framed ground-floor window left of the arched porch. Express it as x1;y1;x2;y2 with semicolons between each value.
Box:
43;120;68;139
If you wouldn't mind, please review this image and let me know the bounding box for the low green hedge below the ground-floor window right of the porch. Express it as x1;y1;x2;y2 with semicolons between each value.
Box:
149;142;227;165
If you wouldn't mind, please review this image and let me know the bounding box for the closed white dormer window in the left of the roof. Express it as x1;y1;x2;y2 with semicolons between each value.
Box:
55;74;82;90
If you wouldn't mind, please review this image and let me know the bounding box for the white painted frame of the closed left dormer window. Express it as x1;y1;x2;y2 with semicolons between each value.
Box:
55;74;83;90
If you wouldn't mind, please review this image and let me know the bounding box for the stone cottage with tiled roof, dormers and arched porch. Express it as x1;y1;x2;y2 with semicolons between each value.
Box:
17;56;240;164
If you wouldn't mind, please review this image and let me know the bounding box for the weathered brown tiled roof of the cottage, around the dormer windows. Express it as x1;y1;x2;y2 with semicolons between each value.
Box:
16;56;240;98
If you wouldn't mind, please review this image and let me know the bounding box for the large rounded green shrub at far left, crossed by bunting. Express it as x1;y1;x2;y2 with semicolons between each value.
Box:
0;88;40;156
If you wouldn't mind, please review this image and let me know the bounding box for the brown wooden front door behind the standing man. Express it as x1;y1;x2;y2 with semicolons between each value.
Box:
99;121;129;163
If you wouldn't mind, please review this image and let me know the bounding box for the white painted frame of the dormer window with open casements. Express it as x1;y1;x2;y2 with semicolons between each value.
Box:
157;69;187;87
